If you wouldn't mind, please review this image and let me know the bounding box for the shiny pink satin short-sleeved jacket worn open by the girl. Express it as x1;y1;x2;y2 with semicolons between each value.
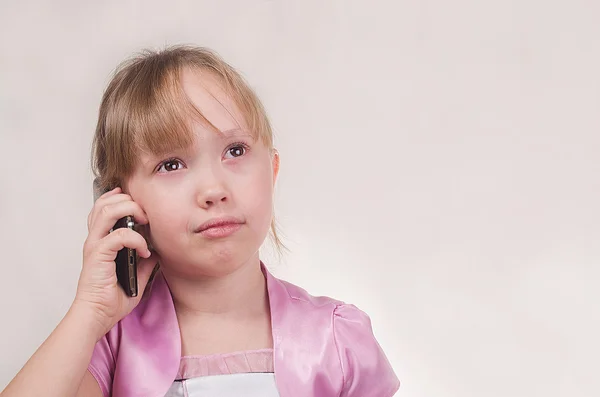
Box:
89;263;400;397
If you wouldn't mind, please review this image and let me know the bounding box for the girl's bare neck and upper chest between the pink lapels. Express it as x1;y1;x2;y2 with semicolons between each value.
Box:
163;257;269;317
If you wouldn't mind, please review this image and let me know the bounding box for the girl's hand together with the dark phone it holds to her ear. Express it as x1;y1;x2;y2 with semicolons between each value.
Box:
74;179;157;336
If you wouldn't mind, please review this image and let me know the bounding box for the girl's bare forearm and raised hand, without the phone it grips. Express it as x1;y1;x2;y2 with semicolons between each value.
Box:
0;188;156;397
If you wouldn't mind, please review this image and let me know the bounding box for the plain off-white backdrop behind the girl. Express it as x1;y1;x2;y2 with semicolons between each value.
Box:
0;0;600;397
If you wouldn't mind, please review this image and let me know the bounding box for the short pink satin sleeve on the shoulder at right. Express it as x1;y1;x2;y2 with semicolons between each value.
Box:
333;304;400;397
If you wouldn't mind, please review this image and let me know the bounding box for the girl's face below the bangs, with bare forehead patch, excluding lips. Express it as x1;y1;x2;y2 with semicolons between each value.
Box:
126;70;279;276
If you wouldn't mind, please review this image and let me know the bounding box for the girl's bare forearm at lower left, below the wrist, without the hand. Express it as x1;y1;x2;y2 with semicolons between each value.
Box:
0;305;102;397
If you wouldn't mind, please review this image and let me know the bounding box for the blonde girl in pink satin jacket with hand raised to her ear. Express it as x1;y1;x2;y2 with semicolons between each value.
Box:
2;46;399;397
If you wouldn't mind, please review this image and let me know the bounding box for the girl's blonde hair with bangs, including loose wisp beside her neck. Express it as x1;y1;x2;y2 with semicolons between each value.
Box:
92;46;285;254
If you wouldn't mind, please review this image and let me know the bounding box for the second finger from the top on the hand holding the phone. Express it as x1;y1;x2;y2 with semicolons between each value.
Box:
89;200;148;241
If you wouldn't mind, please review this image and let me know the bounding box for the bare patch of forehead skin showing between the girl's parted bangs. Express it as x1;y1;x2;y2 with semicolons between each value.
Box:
181;68;248;132
